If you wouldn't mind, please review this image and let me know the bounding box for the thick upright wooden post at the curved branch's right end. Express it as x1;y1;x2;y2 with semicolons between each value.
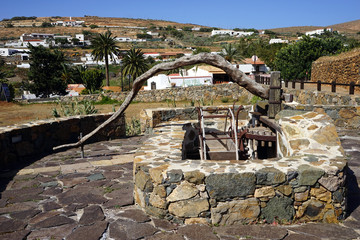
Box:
268;71;281;119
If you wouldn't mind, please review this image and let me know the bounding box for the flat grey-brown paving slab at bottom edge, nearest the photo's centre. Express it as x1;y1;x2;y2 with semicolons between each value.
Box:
178;224;218;240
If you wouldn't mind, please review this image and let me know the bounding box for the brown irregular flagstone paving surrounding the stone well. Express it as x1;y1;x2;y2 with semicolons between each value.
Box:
0;130;360;240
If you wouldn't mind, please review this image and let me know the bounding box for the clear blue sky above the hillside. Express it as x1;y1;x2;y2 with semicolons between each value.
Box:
0;0;360;29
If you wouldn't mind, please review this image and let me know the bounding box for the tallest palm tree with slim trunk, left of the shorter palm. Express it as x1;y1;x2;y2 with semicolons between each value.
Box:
91;31;120;86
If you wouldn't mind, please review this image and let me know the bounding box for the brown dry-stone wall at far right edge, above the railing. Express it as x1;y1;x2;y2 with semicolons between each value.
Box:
311;49;360;84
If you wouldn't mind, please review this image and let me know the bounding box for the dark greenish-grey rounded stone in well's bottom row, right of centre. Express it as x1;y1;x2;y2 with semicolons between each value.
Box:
261;197;295;223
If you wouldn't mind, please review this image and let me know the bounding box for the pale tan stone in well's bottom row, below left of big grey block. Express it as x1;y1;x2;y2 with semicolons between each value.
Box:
169;199;209;217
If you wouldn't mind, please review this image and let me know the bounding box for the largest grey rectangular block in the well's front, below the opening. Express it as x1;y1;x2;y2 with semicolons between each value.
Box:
205;173;256;200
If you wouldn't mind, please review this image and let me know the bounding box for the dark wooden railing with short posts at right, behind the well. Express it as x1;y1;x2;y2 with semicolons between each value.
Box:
255;75;360;95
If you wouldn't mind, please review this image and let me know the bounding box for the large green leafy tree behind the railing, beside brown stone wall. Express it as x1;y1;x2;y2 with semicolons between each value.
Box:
274;36;346;80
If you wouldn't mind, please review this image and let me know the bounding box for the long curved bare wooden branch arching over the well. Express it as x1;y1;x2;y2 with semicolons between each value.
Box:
53;53;269;150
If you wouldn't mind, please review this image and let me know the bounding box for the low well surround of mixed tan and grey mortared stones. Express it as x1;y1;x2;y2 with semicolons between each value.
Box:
134;109;347;225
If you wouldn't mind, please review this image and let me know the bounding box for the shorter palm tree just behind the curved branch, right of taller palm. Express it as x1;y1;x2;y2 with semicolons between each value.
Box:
122;47;149;89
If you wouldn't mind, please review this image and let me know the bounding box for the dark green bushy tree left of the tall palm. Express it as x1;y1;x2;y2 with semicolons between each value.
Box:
24;45;67;97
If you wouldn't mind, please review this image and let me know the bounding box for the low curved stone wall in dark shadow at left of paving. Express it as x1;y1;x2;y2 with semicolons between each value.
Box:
0;113;126;170
